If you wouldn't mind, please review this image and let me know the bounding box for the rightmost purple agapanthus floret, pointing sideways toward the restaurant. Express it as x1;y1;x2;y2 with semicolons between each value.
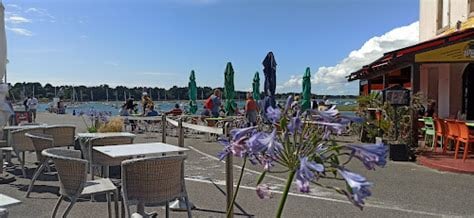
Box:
344;144;388;170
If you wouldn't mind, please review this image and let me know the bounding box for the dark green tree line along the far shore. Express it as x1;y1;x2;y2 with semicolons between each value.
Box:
9;82;356;101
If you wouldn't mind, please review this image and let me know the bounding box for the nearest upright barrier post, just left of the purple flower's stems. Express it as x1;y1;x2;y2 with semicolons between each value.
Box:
224;122;234;218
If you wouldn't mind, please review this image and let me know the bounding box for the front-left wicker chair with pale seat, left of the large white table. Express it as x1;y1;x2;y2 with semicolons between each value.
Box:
42;148;118;218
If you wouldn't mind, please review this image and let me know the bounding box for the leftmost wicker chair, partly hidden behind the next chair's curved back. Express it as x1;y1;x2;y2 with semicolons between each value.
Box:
11;127;43;178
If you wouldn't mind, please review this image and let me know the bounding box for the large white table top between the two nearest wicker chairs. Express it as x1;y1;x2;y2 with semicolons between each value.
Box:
92;142;189;158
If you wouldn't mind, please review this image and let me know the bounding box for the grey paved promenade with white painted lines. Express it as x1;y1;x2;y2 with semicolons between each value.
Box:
0;114;474;217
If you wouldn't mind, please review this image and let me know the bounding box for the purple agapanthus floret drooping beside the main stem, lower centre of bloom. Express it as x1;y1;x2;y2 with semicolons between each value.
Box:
296;157;324;193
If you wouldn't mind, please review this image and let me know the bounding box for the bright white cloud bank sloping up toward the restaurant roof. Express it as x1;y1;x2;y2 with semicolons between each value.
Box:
278;21;419;94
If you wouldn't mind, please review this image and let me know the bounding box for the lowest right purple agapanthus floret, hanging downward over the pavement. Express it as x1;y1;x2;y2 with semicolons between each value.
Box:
337;169;373;209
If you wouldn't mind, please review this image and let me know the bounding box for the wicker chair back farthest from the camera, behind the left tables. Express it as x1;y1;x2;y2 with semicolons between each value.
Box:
44;125;76;148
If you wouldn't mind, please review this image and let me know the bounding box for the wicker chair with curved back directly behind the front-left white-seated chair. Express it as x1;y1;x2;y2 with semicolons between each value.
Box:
25;133;54;198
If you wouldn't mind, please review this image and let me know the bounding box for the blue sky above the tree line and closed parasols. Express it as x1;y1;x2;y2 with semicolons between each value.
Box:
3;0;419;94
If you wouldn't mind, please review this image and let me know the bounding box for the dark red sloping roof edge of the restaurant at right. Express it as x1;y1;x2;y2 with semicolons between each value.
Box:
346;28;474;81
